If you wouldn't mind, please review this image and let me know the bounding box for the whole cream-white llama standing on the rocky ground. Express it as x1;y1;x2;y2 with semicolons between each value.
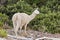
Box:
12;9;39;36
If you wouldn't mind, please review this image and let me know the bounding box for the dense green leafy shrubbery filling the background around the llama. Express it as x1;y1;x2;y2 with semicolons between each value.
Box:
0;0;60;33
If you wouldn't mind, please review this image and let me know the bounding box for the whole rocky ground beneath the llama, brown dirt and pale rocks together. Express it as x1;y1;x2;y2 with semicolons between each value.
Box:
0;29;60;40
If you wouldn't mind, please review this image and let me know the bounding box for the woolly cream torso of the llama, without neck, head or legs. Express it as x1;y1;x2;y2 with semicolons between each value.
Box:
12;13;30;26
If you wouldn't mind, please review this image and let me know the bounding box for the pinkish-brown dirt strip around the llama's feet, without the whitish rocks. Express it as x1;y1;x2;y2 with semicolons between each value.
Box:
6;29;60;38
